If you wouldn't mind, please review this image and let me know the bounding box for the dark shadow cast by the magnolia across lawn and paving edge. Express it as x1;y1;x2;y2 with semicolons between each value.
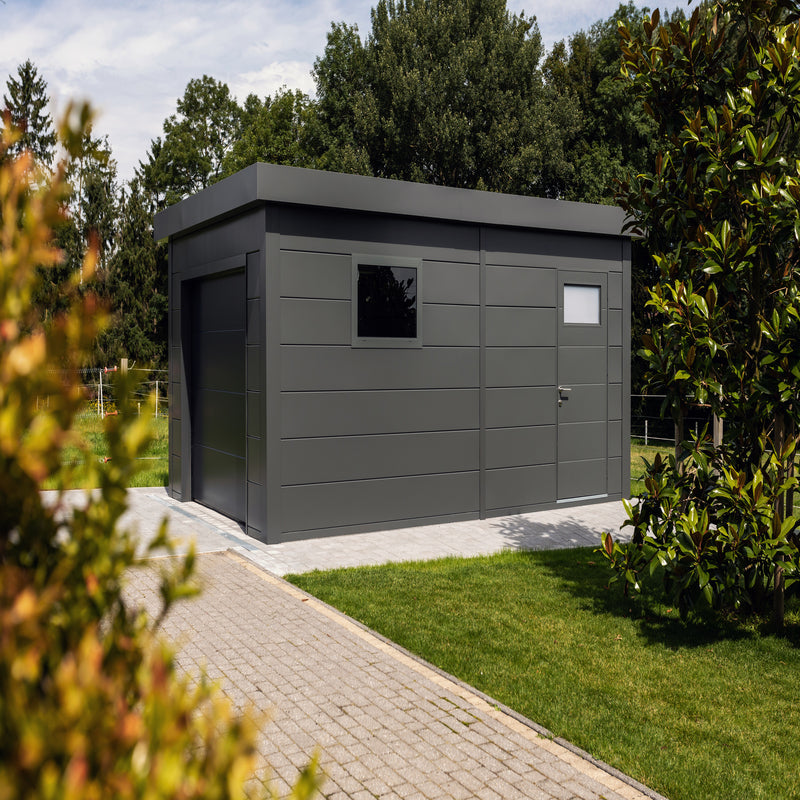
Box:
499;518;800;650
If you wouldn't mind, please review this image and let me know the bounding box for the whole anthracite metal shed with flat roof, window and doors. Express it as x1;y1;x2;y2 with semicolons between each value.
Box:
155;164;630;542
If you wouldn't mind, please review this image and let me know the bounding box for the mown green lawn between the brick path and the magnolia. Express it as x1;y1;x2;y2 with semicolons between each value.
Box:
289;549;800;800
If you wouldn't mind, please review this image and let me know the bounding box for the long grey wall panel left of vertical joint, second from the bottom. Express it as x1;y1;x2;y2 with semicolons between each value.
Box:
281;431;479;486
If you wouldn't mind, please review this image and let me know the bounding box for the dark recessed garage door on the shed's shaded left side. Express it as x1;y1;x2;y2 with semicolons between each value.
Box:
190;272;247;521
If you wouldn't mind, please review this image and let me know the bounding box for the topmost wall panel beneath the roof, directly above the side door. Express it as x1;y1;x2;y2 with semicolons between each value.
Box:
483;227;622;272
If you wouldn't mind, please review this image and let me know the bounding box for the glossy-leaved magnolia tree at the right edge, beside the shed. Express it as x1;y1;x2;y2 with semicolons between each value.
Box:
604;0;800;626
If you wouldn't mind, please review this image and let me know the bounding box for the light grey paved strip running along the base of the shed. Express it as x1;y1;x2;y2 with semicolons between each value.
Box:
47;488;630;575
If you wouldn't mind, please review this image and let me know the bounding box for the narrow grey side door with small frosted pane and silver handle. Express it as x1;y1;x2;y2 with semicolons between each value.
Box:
555;271;608;502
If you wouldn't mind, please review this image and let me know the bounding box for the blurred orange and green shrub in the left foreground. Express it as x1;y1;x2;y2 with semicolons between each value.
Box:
0;110;318;800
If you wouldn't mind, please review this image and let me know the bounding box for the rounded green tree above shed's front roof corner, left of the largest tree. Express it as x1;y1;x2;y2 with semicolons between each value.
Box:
222;88;314;175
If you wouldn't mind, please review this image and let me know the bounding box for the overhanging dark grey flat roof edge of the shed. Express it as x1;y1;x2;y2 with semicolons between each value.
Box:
154;163;627;240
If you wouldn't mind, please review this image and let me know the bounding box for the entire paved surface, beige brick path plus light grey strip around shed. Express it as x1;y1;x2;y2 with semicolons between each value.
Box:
98;489;664;800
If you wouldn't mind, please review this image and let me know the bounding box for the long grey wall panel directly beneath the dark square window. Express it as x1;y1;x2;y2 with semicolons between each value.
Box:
281;346;478;391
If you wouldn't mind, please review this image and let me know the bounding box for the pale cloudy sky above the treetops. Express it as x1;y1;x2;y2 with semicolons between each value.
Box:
0;0;686;181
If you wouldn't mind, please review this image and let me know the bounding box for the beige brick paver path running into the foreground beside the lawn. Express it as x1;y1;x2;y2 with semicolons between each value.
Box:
129;552;657;800
